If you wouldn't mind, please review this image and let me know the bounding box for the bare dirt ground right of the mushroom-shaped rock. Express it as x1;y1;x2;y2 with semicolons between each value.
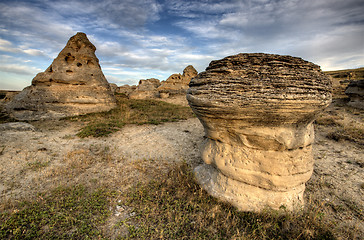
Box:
306;99;364;239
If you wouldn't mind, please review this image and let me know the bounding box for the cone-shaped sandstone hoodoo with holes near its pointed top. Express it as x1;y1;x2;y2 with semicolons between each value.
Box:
6;33;116;120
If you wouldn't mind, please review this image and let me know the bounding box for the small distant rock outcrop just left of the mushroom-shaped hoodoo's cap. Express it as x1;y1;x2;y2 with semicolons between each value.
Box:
157;65;197;98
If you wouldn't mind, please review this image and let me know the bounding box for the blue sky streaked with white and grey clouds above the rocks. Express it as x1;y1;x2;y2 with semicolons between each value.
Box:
0;0;364;90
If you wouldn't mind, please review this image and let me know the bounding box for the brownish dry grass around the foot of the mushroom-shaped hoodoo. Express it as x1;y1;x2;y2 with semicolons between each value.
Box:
119;164;334;239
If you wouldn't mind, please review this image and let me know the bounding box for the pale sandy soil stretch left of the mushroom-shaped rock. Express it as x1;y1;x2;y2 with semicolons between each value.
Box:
0;119;203;200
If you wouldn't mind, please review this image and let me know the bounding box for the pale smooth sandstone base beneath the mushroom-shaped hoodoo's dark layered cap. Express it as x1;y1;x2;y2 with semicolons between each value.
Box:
195;124;314;211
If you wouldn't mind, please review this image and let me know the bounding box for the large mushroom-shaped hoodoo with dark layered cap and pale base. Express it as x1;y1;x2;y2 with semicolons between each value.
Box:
187;53;331;211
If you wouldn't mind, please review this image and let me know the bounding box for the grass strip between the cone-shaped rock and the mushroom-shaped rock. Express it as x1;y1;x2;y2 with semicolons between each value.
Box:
66;94;194;138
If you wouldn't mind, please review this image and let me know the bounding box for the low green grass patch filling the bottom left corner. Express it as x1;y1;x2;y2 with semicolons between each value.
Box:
0;186;112;239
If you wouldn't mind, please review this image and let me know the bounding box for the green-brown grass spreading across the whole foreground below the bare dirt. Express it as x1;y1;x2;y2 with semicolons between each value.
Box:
0;163;335;239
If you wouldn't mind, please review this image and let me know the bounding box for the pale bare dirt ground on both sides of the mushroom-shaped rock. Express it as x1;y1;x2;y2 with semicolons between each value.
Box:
0;99;364;239
